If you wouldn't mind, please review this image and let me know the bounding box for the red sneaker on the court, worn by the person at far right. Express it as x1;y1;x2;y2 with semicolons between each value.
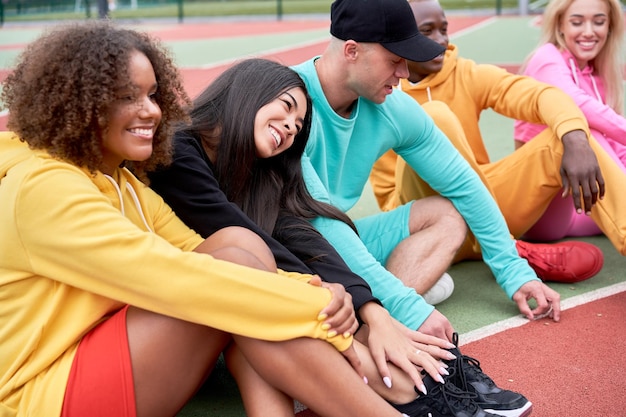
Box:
515;240;604;283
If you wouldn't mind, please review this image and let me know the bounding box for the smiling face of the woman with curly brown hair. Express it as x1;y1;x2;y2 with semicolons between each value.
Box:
101;51;161;174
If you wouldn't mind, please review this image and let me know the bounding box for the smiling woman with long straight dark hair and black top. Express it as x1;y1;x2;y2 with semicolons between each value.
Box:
150;59;478;415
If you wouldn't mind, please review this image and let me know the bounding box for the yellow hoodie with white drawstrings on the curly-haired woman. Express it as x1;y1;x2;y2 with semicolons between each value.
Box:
0;133;352;417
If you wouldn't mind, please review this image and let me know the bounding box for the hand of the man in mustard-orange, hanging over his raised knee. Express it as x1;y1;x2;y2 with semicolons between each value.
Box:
561;130;604;215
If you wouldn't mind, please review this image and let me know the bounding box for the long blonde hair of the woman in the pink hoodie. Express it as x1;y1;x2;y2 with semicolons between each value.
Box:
539;0;624;114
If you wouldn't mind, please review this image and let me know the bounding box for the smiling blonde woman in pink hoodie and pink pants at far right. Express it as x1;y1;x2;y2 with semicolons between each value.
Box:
515;0;626;241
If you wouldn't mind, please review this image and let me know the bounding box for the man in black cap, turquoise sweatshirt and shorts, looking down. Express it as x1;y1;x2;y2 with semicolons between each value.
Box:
294;0;540;416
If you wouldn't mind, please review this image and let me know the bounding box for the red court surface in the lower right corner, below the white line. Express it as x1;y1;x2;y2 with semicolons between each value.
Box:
298;292;626;417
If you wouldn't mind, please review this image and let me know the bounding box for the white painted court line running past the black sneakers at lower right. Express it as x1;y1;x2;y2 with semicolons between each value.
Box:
459;282;626;346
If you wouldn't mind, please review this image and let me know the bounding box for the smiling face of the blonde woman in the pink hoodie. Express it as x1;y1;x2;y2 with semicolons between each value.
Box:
559;0;609;69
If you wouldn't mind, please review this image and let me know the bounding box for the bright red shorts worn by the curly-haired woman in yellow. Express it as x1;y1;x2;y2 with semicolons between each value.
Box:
61;306;136;417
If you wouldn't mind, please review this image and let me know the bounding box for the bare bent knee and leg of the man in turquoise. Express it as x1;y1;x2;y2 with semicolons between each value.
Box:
386;196;467;294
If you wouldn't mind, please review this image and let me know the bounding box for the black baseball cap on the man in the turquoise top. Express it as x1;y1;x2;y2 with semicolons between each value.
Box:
330;0;445;62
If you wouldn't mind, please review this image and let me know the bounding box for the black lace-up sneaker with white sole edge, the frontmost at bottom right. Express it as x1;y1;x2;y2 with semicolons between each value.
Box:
444;333;533;417
